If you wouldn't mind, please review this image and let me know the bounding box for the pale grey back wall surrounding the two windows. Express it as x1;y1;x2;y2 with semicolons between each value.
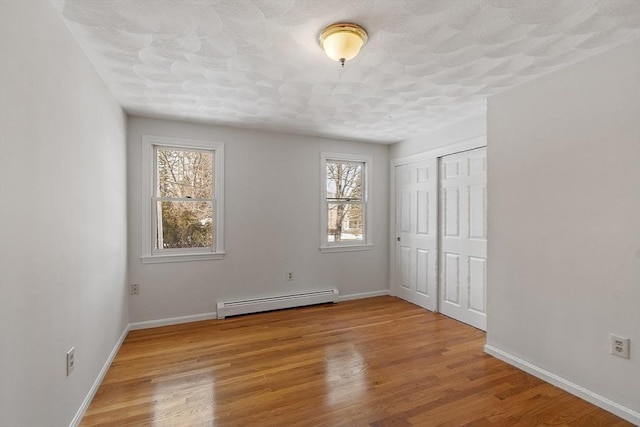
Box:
128;117;388;322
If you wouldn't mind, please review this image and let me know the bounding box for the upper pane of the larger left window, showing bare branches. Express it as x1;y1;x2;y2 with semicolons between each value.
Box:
156;148;213;199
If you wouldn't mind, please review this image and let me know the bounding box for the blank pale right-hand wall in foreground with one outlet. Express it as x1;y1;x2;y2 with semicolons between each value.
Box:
487;41;640;422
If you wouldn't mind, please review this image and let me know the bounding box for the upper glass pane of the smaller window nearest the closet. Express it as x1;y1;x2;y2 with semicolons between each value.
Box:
327;161;364;201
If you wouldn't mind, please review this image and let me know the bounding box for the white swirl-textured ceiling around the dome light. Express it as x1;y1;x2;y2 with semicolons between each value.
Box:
51;0;640;143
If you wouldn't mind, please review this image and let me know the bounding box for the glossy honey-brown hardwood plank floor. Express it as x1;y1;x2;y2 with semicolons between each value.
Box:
81;297;631;427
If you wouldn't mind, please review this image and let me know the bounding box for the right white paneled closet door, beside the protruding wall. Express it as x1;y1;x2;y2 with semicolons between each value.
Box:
439;148;487;330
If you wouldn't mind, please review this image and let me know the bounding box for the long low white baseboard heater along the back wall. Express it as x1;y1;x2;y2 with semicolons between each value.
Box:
216;288;338;319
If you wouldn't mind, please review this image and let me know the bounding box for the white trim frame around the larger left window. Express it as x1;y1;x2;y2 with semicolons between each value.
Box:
140;135;225;264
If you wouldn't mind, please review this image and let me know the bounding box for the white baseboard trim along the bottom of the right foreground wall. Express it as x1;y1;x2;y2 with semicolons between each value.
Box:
484;344;640;425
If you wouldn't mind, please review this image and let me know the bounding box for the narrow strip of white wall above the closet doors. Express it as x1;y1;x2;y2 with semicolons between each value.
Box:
389;113;487;159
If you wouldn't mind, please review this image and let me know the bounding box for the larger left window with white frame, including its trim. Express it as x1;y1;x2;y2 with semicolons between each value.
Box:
141;136;224;263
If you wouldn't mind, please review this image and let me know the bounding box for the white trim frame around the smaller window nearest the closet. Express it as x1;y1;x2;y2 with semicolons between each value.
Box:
320;152;373;253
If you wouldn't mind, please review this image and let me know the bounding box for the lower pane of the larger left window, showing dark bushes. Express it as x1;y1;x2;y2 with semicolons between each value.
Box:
156;201;213;249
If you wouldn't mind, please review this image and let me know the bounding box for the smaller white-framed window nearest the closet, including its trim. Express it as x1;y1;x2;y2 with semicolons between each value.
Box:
320;153;372;252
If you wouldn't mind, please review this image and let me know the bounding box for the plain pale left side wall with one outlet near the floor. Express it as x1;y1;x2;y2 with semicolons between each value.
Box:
0;0;128;427
